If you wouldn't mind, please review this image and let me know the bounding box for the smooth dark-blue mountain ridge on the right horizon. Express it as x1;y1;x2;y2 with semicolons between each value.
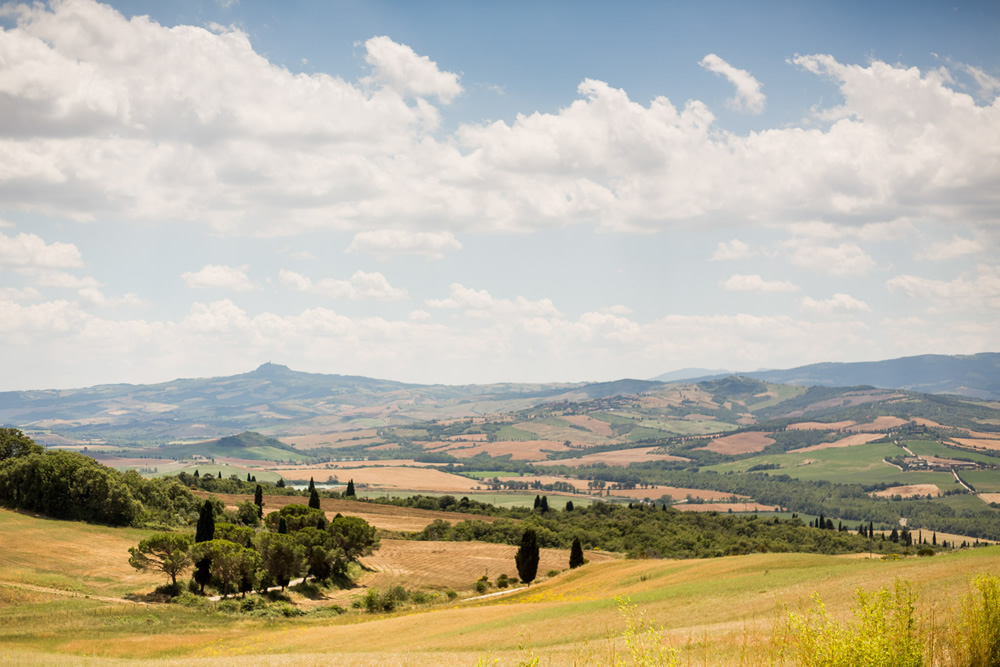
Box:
672;352;1000;400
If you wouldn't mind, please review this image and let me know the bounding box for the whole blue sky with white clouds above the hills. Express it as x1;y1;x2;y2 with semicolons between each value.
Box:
0;0;1000;391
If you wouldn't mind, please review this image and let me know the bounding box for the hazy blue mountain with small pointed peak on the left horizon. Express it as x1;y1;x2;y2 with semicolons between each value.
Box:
0;363;659;444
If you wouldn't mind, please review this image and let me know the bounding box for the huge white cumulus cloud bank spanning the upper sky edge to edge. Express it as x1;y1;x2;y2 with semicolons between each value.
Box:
0;0;1000;240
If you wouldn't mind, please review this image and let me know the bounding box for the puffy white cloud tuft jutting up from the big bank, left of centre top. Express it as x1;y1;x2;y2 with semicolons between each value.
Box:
365;35;462;104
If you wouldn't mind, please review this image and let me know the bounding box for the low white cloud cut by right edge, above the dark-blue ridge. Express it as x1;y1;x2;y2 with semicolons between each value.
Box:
886;264;1000;312
